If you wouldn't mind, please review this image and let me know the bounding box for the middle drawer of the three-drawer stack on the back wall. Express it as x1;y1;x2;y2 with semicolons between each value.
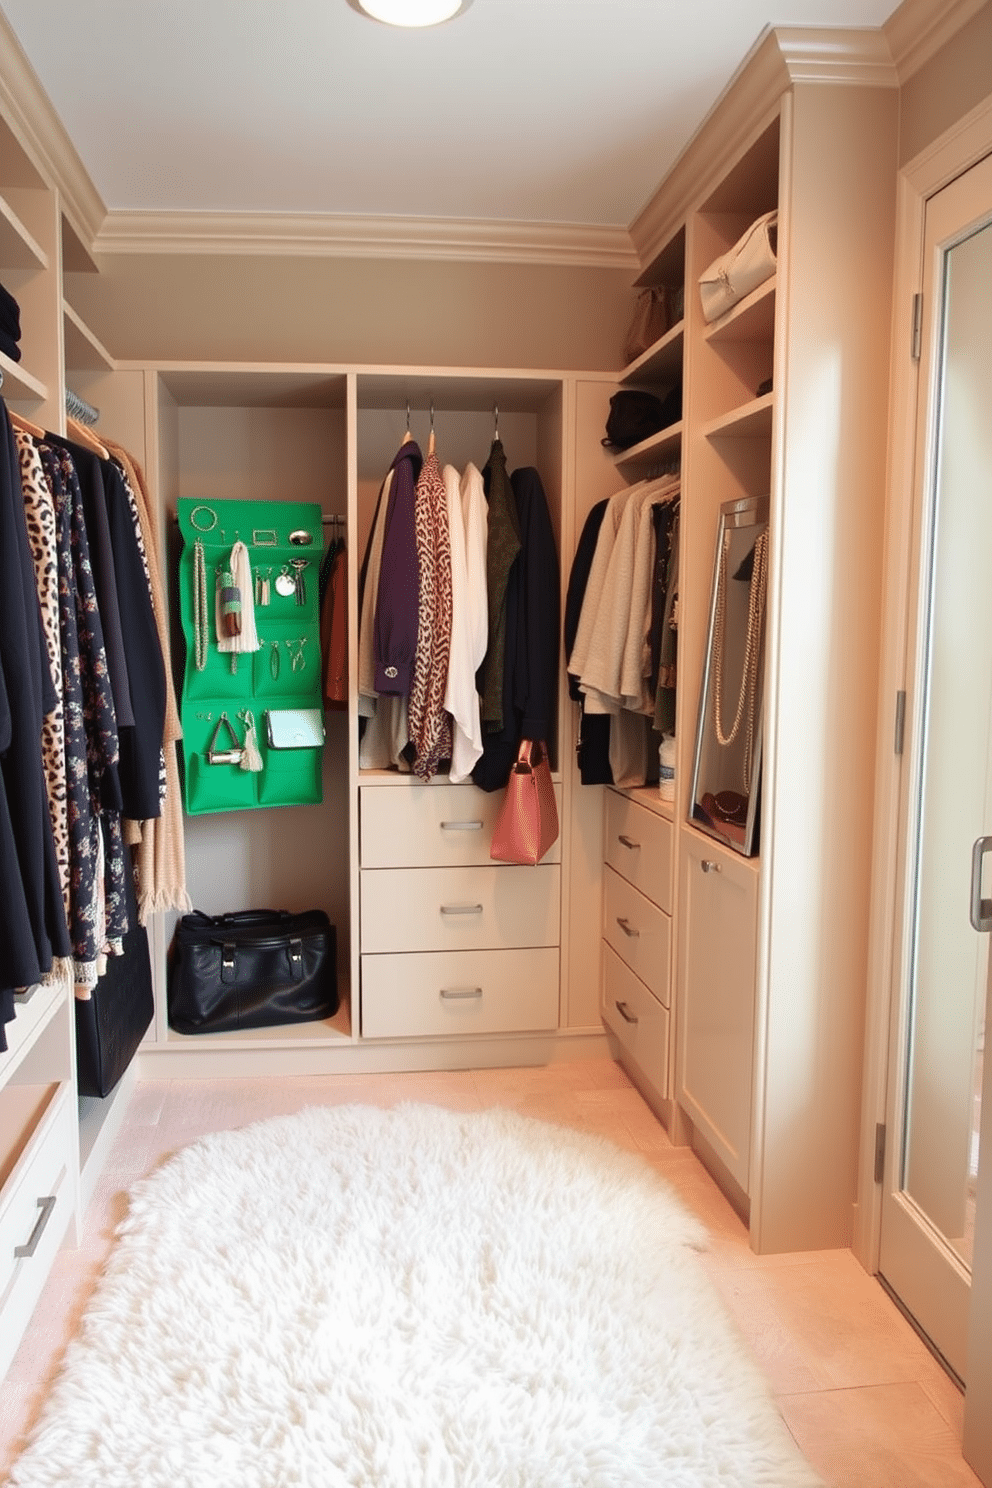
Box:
361;865;561;952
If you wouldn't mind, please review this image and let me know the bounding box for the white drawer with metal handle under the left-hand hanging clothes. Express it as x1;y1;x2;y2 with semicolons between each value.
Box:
0;1083;76;1376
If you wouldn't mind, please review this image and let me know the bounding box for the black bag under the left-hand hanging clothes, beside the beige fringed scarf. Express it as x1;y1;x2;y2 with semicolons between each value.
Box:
76;873;155;1097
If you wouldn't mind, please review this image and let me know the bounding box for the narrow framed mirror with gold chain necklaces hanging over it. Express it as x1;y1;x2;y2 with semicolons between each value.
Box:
690;496;769;857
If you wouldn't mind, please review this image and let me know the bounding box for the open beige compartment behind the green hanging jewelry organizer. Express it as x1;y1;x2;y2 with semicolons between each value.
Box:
151;363;354;1073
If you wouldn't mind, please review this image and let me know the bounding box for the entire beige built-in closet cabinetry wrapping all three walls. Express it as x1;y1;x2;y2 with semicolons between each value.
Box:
0;14;928;1380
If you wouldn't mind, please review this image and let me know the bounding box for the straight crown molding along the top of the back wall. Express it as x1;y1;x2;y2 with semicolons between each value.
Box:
94;211;638;271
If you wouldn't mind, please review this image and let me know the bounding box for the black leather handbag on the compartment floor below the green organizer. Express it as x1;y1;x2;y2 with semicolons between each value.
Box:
168;909;338;1033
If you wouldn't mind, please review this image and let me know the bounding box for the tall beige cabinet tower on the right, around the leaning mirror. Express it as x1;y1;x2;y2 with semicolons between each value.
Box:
604;31;897;1251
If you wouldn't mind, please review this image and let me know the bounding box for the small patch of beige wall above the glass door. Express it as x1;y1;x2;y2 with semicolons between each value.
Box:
900;4;992;165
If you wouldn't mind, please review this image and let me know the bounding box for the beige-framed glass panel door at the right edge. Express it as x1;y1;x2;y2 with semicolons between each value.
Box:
880;151;992;1378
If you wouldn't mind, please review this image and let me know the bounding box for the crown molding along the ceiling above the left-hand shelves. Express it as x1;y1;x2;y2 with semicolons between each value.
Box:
0;12;107;251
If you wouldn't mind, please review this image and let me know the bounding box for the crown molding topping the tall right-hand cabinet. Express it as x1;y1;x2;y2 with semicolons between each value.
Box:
631;21;898;272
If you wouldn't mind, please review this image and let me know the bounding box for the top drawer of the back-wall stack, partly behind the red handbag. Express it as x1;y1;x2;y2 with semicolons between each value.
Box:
360;784;561;868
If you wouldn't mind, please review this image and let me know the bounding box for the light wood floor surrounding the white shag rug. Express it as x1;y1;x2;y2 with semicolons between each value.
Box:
0;1059;979;1488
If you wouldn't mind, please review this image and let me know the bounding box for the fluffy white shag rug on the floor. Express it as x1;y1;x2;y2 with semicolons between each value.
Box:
10;1104;821;1488
